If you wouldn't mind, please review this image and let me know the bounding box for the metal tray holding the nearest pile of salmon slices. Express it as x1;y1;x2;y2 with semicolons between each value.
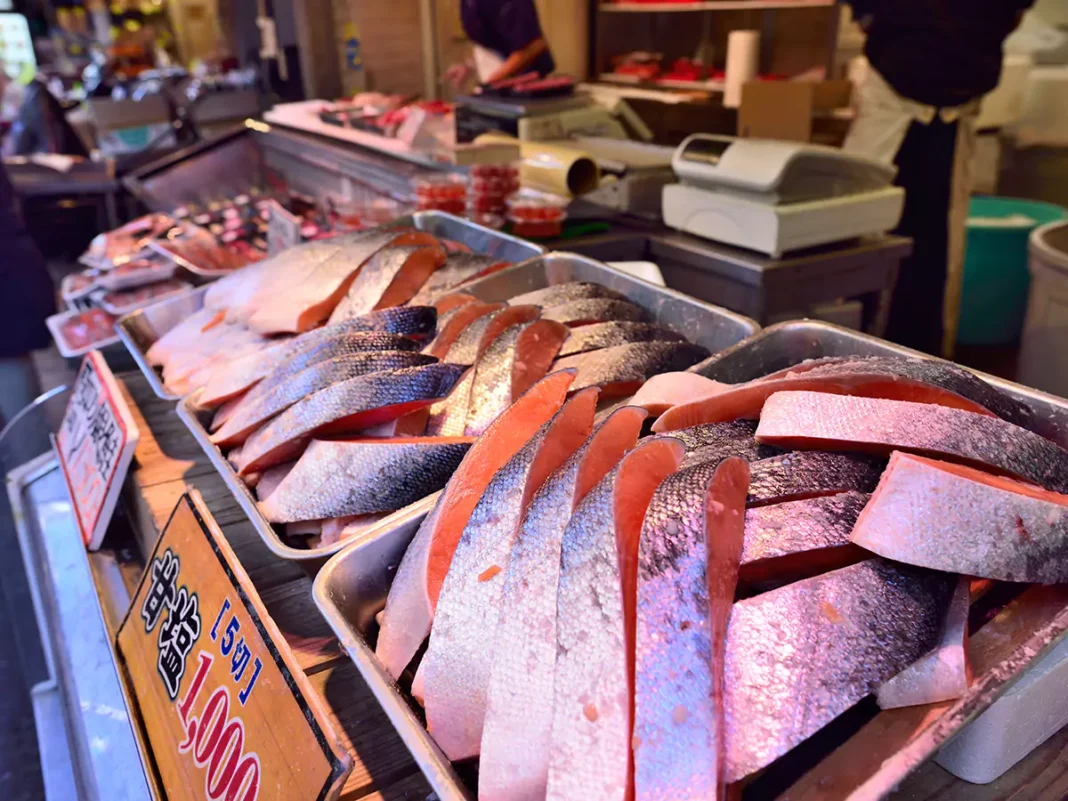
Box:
313;320;1068;801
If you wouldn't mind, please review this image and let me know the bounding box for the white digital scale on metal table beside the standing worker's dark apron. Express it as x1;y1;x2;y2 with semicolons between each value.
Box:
663;134;905;257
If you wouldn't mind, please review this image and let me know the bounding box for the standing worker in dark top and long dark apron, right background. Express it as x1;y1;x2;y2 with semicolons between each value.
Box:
843;0;1033;356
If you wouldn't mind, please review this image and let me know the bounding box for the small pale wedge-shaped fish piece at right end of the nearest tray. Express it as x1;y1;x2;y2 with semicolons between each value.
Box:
876;576;972;709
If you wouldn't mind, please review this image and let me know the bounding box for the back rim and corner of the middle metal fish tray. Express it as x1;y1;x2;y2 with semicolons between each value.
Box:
464;253;760;354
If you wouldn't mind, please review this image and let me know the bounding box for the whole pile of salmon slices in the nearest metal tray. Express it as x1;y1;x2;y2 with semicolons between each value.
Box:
376;357;1068;800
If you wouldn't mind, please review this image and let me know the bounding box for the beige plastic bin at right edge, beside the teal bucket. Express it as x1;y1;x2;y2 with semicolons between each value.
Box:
1017;220;1068;397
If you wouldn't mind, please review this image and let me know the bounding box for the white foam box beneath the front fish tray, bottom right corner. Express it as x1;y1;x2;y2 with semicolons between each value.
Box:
935;639;1068;784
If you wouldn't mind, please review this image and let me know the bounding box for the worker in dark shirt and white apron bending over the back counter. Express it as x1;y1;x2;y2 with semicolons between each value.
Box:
445;0;556;85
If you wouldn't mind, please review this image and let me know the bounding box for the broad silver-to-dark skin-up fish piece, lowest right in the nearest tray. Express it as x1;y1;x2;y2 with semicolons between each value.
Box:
724;559;957;782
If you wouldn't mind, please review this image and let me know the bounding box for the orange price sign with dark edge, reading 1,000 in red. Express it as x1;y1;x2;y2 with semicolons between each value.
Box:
115;488;352;801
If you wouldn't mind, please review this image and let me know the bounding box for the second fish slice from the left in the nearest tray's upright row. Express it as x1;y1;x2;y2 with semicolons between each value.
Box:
420;390;597;759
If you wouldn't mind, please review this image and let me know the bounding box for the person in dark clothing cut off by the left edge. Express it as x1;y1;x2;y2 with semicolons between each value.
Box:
0;166;56;425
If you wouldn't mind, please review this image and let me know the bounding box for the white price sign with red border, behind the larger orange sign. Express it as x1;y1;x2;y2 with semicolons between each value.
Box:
56;350;140;550
